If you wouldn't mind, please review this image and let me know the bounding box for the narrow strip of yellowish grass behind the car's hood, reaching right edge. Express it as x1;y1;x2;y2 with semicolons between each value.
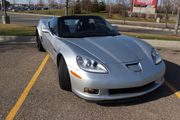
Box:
122;32;180;41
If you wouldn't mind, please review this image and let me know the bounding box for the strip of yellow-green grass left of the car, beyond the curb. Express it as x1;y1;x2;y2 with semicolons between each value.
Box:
0;23;35;36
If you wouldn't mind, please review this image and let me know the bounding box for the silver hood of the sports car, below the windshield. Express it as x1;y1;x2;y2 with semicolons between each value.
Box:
68;35;148;63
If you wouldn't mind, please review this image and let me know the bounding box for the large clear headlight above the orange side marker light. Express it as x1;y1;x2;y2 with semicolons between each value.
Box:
77;56;108;73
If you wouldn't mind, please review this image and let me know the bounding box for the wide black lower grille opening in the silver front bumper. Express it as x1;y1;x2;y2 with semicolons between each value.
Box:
109;82;155;95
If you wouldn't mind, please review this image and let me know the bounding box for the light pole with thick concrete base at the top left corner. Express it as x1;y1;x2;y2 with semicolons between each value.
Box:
2;0;10;24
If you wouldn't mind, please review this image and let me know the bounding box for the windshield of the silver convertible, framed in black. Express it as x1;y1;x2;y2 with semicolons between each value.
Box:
59;16;119;38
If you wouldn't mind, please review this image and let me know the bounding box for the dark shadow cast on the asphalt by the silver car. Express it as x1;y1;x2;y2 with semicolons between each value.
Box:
97;60;180;107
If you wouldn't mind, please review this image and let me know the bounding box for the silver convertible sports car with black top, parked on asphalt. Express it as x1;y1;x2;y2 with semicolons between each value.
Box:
36;16;165;101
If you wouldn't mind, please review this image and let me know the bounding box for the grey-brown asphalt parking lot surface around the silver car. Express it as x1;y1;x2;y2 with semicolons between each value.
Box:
0;38;180;120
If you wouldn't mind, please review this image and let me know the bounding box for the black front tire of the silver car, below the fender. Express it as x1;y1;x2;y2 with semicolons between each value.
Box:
58;57;71;91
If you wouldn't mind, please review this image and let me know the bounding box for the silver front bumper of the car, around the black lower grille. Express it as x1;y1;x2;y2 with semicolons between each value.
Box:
70;61;165;101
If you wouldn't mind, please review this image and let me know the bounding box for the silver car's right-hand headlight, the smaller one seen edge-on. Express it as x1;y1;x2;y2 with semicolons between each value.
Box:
151;48;162;65
